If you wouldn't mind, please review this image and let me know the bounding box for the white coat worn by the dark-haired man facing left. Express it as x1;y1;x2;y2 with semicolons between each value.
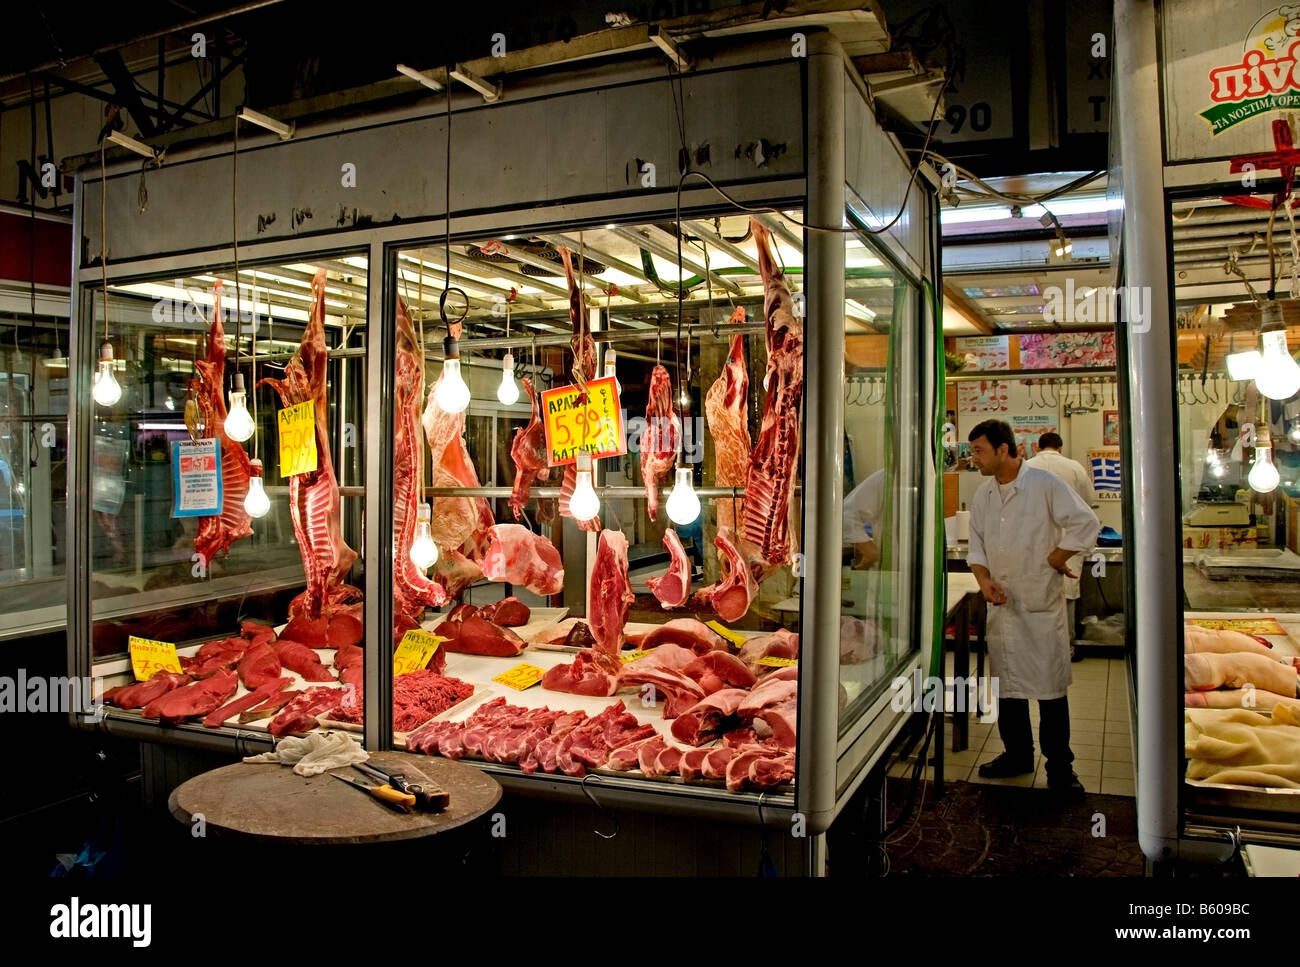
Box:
967;461;1099;699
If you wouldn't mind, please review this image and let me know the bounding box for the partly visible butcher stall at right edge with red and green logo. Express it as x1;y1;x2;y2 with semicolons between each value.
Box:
1112;0;1300;866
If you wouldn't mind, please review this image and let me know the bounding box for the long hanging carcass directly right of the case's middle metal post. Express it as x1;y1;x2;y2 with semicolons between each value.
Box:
393;296;447;628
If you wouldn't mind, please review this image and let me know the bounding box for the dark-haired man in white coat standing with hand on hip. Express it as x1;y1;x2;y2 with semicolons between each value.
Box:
967;420;1099;798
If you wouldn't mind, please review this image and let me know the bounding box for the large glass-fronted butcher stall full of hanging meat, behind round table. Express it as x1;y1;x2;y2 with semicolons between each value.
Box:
68;24;941;873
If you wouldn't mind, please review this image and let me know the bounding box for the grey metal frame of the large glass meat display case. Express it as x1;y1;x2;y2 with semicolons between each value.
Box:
68;31;941;841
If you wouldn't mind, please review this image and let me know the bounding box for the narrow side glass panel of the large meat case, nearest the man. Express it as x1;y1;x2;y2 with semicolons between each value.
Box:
840;237;923;732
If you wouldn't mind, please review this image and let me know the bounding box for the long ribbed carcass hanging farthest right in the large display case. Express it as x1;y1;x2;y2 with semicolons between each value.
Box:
743;218;803;577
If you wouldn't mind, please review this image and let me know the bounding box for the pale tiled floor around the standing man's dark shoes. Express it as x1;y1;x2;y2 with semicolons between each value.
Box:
889;655;1134;795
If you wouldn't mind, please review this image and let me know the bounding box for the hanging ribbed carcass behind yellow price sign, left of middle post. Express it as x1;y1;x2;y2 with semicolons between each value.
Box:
259;269;356;619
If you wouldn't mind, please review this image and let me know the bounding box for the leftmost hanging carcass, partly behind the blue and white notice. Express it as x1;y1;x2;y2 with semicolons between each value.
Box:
190;281;252;563
